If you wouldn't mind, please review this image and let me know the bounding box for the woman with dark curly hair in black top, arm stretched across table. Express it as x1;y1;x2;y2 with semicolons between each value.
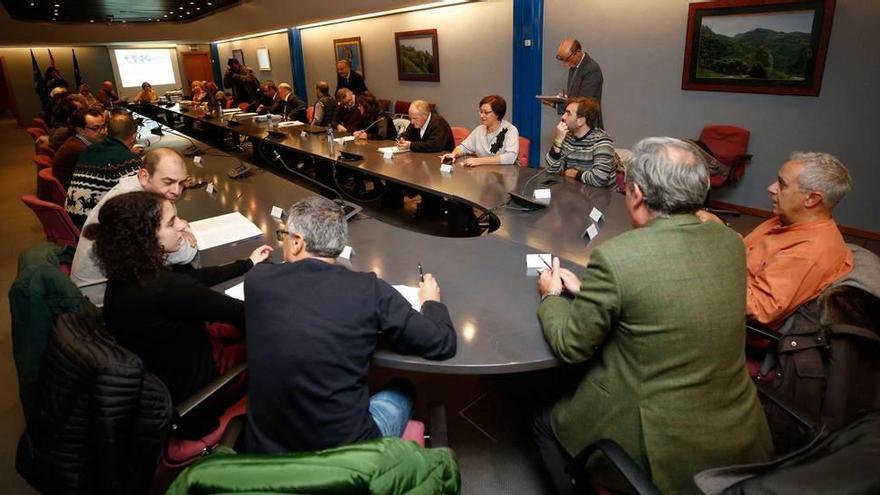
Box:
83;192;272;432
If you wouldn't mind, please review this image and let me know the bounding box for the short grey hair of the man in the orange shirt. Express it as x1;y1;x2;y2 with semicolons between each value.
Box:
788;151;852;210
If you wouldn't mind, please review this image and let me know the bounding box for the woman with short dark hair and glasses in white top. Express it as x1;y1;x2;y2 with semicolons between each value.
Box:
443;95;524;167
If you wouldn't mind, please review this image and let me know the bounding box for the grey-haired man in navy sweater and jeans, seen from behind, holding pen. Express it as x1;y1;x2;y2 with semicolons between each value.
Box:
244;196;456;453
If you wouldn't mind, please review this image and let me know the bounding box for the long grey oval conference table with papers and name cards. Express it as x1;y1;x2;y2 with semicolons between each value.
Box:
137;105;630;375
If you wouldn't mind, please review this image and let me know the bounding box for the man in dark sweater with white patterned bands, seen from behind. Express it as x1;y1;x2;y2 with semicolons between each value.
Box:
66;110;141;228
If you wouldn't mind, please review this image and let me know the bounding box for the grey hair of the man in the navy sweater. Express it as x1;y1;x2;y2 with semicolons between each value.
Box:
287;196;348;258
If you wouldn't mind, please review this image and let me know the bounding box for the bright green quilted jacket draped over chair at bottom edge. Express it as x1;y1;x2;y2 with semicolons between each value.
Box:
167;437;461;495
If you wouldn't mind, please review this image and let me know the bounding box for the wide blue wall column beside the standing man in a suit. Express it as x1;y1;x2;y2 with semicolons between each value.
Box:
512;0;544;167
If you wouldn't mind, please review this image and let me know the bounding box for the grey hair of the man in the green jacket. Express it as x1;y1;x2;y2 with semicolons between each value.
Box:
626;137;709;215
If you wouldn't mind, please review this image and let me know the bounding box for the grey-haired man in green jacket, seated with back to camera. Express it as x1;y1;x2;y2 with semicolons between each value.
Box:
535;138;773;493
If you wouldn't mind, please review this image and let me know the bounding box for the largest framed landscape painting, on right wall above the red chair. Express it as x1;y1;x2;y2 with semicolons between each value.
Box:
681;0;835;96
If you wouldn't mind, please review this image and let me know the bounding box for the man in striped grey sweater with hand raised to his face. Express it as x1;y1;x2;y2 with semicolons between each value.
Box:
546;97;620;187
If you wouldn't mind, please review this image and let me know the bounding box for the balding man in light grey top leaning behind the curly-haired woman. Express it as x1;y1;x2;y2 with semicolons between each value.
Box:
70;148;198;306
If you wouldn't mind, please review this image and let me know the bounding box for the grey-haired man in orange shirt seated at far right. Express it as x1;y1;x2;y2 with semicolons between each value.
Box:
700;152;853;329
